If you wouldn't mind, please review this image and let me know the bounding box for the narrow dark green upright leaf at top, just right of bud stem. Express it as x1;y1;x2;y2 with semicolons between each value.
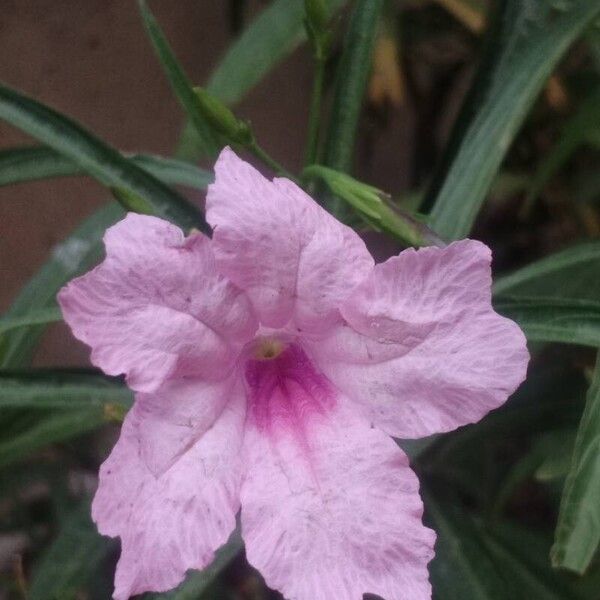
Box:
325;0;384;172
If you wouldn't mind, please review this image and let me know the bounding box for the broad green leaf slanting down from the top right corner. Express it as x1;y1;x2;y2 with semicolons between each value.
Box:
425;0;600;240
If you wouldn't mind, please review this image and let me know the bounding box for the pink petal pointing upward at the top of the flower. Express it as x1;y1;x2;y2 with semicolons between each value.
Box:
206;148;373;330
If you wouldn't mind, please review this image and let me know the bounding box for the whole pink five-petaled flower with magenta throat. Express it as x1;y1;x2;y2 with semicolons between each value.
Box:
59;149;528;600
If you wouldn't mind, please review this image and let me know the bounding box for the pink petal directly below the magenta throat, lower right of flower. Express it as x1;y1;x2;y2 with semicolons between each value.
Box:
241;398;435;600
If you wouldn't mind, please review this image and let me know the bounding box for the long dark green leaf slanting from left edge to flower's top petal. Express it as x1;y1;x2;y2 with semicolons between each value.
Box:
0;79;208;231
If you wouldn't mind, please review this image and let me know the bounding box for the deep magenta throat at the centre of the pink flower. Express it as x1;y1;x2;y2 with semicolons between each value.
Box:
245;338;335;439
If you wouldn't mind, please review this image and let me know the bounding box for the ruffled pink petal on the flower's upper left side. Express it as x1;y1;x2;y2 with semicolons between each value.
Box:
59;214;257;392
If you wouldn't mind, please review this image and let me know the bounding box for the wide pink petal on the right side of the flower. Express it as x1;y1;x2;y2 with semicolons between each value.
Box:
309;240;529;438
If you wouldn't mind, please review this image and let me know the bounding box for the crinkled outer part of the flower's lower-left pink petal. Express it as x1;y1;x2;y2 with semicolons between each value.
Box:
92;382;245;600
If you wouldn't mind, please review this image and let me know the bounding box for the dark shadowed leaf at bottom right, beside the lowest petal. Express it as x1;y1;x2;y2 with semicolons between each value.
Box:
425;495;592;600
